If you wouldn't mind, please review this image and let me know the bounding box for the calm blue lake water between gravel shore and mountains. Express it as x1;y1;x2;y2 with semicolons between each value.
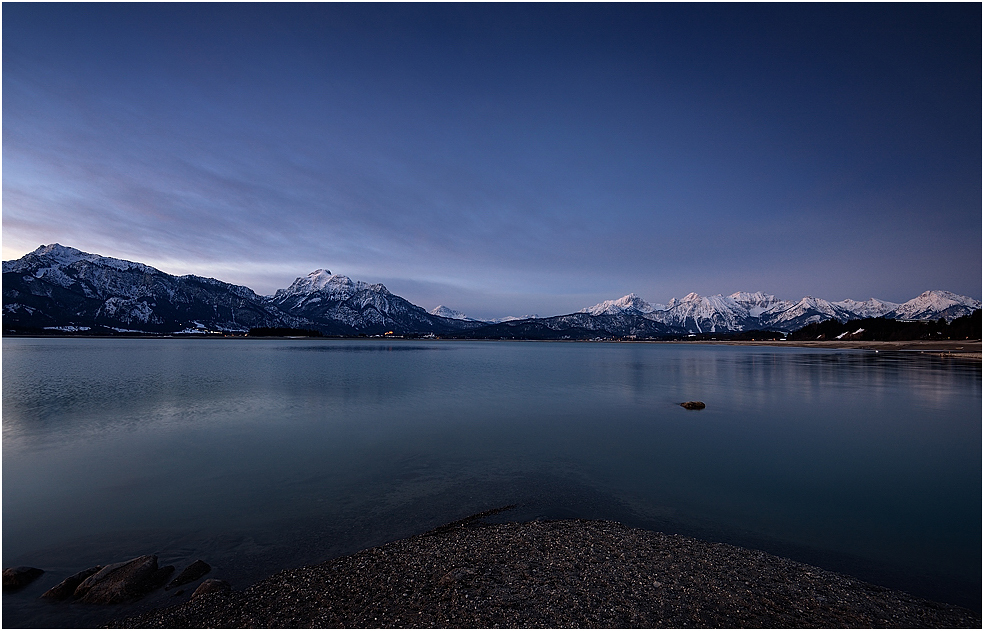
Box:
3;339;981;627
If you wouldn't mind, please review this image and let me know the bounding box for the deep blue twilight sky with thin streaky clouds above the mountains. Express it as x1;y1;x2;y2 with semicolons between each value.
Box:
2;3;982;318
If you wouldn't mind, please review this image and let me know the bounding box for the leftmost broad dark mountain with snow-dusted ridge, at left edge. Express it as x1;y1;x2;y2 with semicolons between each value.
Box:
3;243;296;332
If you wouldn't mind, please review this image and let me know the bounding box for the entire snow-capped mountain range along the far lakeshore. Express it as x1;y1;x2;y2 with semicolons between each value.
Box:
3;244;981;339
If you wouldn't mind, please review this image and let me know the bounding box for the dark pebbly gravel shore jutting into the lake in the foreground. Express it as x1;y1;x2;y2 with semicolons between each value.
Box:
110;511;981;628
